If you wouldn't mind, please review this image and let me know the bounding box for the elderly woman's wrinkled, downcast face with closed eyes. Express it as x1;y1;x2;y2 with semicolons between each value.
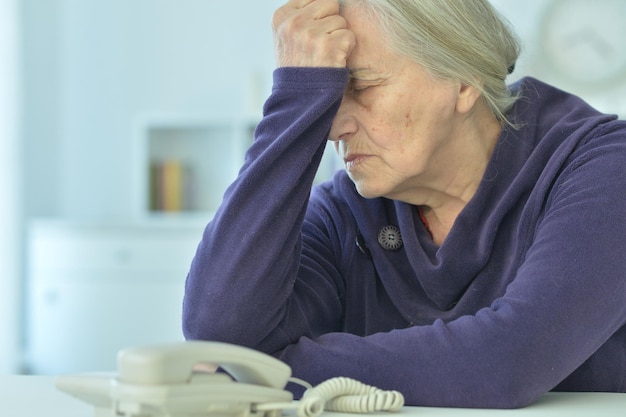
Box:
330;6;480;204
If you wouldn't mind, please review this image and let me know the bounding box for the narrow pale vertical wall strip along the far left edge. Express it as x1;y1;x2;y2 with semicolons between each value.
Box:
0;0;21;374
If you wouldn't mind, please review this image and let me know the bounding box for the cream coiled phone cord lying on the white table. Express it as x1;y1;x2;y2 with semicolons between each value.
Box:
256;377;404;417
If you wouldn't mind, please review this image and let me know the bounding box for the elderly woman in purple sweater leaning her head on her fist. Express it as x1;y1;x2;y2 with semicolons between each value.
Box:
184;0;626;408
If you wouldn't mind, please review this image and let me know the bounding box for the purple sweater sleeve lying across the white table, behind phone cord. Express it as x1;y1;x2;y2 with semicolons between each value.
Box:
281;125;626;408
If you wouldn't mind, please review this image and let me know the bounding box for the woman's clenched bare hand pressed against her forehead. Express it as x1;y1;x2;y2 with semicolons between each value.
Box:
272;0;355;68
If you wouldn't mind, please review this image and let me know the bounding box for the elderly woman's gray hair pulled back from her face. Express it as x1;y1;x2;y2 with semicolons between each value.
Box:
340;0;520;124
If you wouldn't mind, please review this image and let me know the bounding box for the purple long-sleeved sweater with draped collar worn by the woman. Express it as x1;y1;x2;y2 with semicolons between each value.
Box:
183;68;626;408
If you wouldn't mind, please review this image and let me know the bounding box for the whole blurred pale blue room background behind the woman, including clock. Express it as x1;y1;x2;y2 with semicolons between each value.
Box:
0;0;626;374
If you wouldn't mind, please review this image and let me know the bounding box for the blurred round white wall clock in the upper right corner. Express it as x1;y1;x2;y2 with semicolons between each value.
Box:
540;0;626;88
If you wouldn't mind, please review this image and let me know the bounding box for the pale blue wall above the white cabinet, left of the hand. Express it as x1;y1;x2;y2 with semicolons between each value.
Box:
26;0;280;220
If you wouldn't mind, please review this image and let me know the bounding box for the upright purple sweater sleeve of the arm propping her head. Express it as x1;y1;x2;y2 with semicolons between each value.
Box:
183;68;348;352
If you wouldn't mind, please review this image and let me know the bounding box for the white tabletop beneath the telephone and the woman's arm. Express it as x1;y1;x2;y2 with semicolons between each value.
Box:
0;375;626;417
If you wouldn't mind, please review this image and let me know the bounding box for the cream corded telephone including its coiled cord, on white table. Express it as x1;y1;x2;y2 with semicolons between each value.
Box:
56;341;404;417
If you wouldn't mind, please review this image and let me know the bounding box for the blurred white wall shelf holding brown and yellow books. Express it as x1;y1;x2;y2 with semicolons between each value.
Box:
137;117;256;217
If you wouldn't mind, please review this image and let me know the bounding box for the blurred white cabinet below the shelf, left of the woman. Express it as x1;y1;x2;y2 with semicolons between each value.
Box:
26;222;204;374
